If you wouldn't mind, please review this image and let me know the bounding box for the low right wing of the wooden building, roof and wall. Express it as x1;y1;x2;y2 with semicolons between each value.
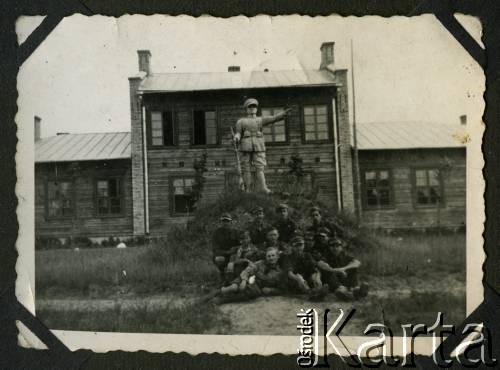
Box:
357;122;466;229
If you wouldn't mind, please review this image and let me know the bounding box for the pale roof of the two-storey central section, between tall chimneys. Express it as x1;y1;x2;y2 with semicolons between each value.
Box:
139;70;338;93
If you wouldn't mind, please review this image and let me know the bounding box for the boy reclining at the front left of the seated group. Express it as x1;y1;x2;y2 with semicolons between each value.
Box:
239;247;286;295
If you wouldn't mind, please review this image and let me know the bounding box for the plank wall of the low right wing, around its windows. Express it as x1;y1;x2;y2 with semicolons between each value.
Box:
359;148;466;229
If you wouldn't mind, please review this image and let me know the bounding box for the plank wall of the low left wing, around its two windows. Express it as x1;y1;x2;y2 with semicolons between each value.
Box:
35;160;133;238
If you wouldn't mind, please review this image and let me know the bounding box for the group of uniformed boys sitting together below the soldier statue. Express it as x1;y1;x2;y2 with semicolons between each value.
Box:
212;204;367;300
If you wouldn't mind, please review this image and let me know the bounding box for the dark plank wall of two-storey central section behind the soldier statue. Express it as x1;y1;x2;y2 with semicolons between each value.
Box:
143;88;342;235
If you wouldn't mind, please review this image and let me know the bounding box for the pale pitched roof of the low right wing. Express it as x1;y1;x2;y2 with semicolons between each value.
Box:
356;122;466;150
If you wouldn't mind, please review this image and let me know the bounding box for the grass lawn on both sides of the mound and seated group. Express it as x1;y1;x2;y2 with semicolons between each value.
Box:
36;234;465;334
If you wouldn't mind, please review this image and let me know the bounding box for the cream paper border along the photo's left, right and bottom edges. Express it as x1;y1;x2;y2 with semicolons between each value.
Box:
16;13;485;355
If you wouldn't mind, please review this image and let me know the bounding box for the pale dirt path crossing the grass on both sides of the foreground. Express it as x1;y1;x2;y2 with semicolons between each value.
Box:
36;276;465;336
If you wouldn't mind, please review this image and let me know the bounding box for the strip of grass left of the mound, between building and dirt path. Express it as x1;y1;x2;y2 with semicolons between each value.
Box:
36;240;218;298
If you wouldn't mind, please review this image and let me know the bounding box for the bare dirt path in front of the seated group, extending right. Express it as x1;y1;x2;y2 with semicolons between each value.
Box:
213;277;465;336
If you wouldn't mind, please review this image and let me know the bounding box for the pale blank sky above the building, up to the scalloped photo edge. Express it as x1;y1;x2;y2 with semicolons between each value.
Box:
16;15;485;137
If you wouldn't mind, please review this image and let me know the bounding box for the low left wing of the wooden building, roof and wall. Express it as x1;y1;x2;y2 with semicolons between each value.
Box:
35;132;133;239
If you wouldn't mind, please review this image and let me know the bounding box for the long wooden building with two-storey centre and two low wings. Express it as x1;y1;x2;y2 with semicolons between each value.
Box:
35;42;466;237
